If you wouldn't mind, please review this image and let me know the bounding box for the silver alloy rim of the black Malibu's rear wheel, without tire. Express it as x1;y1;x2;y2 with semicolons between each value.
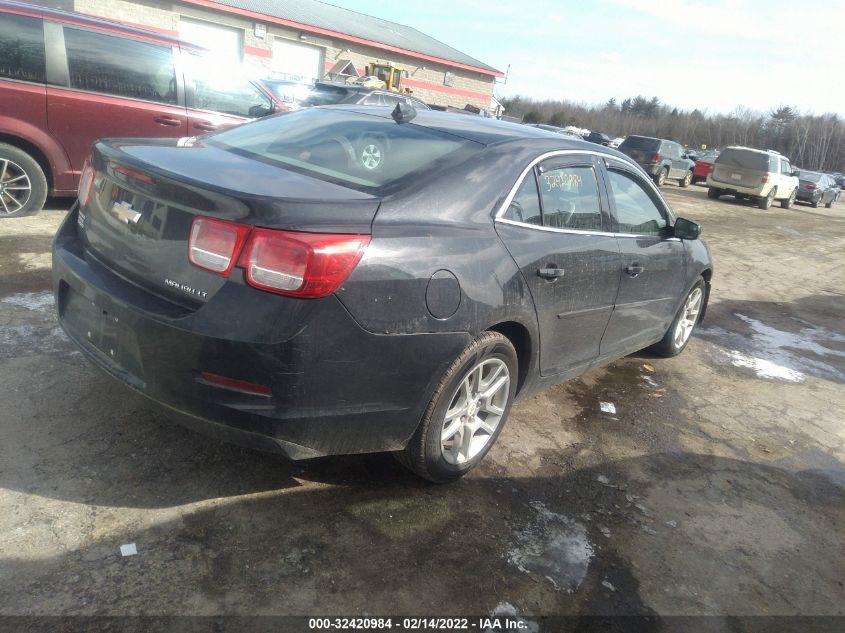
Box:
440;358;510;465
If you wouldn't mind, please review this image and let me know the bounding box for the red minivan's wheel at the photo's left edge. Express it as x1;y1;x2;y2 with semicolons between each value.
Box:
0;143;47;218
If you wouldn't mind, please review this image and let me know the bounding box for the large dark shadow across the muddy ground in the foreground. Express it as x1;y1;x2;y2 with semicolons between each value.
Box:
0;452;845;620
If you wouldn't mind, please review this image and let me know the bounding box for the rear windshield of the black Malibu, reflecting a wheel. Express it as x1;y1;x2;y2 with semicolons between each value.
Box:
205;108;484;193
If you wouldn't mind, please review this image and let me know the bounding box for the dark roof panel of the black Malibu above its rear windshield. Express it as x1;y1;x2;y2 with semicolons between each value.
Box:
328;105;612;149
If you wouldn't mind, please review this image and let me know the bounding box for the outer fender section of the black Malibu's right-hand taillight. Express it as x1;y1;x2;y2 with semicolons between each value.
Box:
240;229;370;299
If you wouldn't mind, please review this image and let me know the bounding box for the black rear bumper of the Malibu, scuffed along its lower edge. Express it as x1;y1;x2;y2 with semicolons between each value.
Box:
53;207;470;459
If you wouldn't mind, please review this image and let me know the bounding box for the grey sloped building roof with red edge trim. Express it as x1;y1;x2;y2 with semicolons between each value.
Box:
182;0;502;76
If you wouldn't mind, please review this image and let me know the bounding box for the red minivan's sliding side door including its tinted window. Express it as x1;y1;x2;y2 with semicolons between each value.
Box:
45;22;188;177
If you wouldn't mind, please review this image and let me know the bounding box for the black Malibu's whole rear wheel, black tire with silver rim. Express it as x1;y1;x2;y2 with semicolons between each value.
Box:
396;332;519;483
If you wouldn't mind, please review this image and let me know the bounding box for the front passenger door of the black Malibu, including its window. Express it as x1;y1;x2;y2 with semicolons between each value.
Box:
601;160;686;356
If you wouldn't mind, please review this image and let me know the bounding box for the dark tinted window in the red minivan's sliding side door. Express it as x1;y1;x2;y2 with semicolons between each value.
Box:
64;27;176;105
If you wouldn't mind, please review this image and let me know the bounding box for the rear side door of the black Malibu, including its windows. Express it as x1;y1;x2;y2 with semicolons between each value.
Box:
496;155;620;375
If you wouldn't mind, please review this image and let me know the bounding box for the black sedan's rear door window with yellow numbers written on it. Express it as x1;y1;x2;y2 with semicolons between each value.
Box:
540;166;602;231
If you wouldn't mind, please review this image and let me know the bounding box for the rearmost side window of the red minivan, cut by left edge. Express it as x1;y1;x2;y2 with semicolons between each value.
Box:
0;13;45;83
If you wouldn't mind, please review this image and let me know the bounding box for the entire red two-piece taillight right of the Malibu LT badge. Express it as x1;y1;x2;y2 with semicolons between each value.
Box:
188;218;370;299
